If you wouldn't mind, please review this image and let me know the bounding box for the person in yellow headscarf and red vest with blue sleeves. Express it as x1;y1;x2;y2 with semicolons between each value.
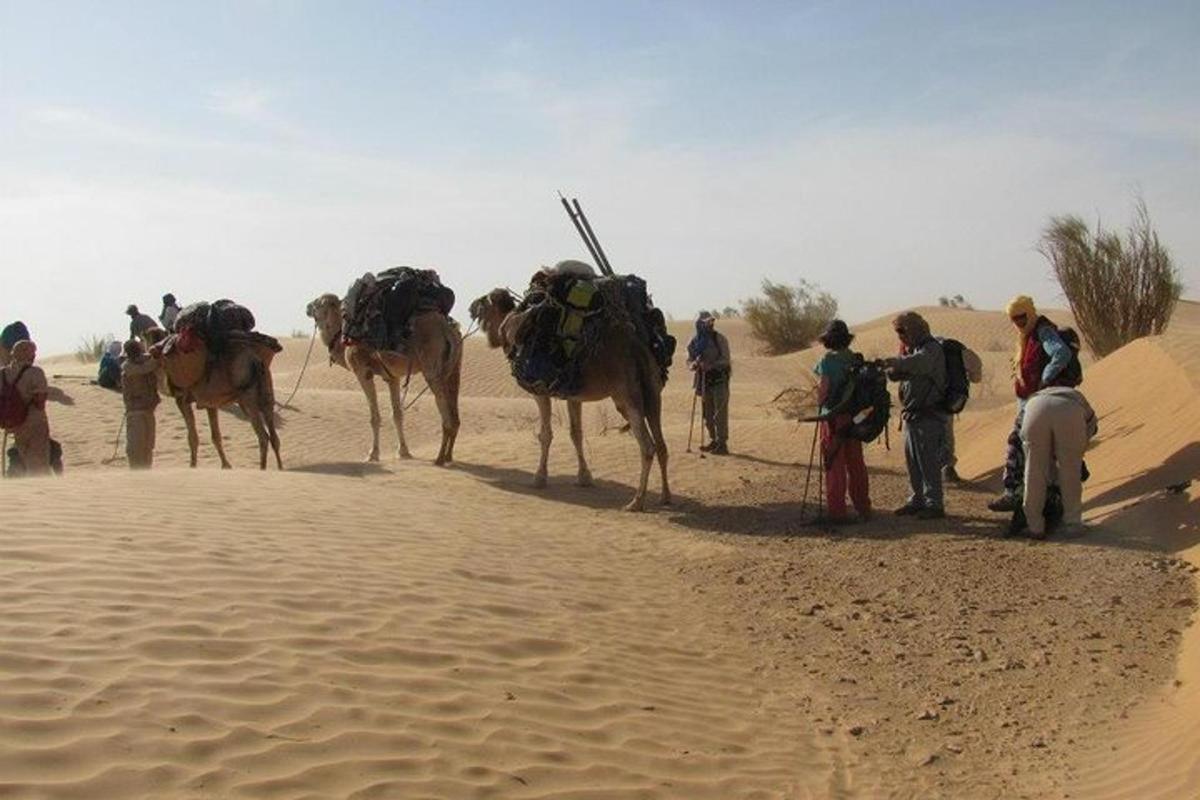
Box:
988;295;1072;512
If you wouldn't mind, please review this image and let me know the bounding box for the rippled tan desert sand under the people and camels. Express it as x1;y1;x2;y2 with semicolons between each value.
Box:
0;302;1200;800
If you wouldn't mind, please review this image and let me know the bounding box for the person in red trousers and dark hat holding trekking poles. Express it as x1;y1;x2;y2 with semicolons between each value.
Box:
812;319;871;524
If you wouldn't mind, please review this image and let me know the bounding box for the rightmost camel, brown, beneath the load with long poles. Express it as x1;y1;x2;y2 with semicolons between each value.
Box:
470;283;671;511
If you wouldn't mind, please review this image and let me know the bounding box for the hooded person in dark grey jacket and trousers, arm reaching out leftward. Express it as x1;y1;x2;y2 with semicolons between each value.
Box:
883;311;946;519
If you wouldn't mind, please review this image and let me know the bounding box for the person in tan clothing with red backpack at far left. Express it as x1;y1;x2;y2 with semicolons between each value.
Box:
0;339;50;475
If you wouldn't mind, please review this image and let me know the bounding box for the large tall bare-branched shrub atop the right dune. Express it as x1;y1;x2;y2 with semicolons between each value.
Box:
1038;198;1183;357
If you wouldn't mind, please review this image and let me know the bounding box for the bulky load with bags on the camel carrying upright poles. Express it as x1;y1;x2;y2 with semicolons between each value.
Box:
509;261;676;398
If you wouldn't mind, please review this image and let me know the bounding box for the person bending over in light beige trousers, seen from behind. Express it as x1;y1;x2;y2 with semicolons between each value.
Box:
1021;386;1099;539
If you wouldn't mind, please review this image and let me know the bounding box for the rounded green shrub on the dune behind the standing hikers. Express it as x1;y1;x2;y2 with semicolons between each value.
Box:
742;279;838;354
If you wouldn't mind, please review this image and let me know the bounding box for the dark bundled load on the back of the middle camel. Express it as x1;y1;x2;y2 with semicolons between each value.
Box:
342;266;454;353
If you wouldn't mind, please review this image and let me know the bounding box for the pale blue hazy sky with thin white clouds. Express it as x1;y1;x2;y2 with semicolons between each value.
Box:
0;0;1200;353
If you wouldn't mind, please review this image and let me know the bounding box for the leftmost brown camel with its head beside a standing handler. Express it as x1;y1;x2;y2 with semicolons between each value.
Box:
143;329;283;469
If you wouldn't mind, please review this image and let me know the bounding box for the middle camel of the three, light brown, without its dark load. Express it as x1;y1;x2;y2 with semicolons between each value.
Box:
306;294;462;467
